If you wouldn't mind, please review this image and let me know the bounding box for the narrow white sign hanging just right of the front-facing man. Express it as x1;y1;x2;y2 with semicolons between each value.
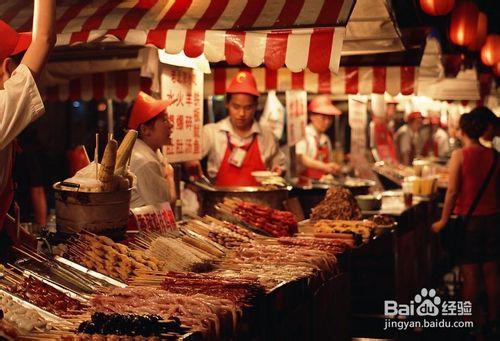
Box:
286;90;307;146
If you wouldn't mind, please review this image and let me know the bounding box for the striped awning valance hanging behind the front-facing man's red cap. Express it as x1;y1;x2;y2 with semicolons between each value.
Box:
205;66;418;96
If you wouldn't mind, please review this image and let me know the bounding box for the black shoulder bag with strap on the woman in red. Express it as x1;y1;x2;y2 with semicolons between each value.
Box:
439;149;498;265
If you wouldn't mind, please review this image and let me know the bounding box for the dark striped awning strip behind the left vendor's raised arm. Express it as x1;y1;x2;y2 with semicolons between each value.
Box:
41;70;151;102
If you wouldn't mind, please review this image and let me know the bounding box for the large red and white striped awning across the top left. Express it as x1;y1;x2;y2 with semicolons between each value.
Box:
0;0;355;72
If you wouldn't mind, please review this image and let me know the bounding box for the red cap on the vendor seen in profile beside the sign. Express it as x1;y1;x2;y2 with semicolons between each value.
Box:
128;91;175;129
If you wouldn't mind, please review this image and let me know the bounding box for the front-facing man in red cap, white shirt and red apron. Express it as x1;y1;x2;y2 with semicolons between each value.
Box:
186;71;285;187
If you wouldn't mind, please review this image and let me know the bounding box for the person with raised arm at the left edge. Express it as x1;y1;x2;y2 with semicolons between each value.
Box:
0;0;55;251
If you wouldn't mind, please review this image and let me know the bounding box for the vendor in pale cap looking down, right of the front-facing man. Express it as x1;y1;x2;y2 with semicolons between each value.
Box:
295;95;342;180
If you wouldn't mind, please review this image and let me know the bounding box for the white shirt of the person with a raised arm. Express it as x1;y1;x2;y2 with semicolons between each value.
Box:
0;64;45;193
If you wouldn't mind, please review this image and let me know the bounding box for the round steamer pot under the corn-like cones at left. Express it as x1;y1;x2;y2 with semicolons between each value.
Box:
53;182;132;235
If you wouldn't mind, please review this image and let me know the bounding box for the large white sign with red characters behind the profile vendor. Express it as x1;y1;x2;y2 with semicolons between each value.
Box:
161;65;203;162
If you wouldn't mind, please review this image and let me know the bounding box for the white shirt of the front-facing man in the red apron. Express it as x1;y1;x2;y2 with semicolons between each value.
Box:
202;117;285;178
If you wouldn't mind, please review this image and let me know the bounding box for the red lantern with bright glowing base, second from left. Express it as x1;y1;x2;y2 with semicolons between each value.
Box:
450;1;479;46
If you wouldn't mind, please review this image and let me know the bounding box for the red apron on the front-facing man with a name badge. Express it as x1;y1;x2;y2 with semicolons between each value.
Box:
215;134;267;187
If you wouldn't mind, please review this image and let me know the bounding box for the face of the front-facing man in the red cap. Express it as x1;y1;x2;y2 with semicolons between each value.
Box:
226;94;257;129
